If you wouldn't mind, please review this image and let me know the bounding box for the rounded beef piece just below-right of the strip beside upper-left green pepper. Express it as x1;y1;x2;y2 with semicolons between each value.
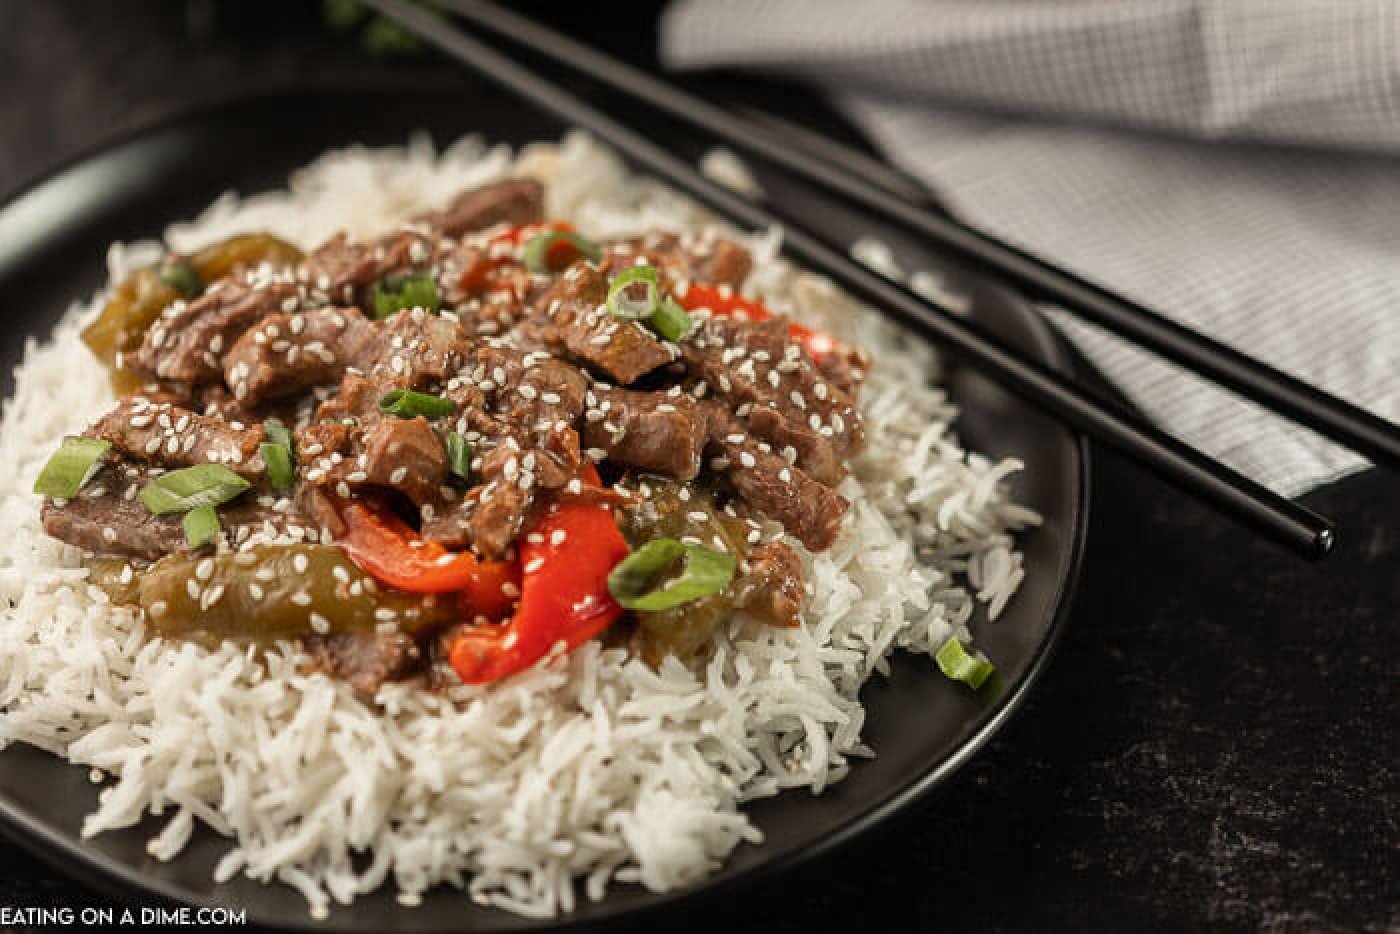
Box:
223;307;374;406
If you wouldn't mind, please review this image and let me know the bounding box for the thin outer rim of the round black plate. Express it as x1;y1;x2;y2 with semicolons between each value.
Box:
0;85;1093;931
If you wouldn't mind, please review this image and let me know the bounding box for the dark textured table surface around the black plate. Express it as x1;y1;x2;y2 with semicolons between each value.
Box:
0;0;1400;933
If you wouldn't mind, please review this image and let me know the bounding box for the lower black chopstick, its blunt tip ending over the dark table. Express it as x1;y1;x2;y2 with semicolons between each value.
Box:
365;0;1334;559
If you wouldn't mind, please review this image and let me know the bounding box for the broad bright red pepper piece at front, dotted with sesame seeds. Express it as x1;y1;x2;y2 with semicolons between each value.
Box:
448;466;627;685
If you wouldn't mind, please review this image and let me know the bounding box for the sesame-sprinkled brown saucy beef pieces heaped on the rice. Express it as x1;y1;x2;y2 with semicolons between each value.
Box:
43;179;864;693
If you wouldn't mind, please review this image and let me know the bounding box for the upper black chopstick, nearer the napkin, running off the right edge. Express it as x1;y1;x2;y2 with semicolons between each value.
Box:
425;0;1400;478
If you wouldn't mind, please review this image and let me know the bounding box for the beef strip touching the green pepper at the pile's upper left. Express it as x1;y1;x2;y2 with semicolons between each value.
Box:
122;275;301;384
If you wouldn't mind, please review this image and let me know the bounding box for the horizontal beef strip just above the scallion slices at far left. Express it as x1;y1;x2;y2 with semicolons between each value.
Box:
87;395;267;480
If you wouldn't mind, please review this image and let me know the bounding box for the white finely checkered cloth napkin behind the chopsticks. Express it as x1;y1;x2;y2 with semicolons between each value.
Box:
661;0;1400;496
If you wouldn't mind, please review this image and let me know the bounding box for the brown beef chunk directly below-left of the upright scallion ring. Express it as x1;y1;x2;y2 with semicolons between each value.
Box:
519;260;676;385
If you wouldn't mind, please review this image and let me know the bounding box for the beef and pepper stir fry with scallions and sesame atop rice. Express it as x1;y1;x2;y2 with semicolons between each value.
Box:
35;179;867;696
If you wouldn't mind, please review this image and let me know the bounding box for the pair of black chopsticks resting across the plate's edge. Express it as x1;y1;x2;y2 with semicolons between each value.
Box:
365;0;1400;559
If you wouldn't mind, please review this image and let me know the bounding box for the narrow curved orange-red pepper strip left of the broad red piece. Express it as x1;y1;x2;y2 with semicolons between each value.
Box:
336;500;519;607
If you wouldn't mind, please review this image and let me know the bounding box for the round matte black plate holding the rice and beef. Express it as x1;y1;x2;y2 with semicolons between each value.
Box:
0;83;1088;931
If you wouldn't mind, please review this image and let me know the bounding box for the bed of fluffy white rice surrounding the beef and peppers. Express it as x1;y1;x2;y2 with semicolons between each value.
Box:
0;136;1036;916
